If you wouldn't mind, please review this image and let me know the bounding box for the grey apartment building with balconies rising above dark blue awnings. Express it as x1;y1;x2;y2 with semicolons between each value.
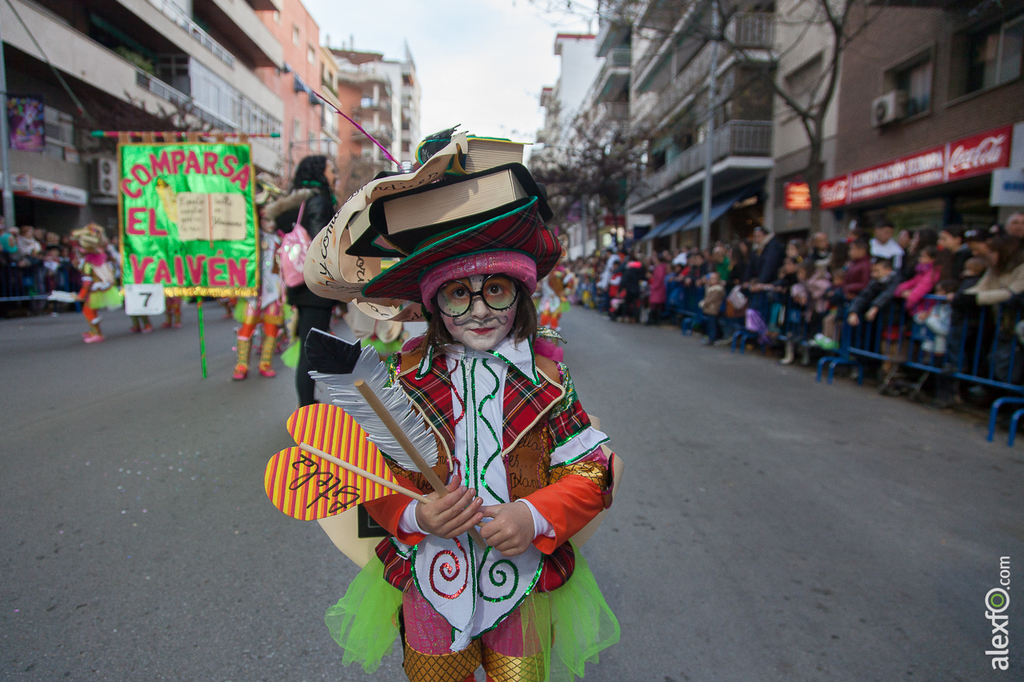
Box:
629;0;775;250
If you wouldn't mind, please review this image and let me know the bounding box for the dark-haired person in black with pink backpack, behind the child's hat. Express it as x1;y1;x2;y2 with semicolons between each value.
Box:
266;155;337;408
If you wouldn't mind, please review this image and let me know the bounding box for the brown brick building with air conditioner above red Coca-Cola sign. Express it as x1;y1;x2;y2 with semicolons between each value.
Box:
821;0;1024;229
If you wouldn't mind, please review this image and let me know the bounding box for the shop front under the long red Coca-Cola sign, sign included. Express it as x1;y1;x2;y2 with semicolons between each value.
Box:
818;125;1014;230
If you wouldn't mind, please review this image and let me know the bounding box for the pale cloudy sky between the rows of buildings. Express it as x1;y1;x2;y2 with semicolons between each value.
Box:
303;0;597;142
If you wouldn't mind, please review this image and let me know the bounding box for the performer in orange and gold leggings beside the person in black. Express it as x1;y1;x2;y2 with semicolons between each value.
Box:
231;218;285;381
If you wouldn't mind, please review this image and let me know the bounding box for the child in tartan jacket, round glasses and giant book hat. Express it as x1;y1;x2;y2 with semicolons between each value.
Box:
305;131;618;682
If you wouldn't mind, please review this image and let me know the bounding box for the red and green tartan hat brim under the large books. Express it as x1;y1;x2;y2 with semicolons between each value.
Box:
362;198;562;303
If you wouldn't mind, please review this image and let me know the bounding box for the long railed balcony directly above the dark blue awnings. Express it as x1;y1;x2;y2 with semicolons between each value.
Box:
629;121;772;210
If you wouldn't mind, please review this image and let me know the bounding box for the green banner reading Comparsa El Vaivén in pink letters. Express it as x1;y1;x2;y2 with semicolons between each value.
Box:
118;142;259;296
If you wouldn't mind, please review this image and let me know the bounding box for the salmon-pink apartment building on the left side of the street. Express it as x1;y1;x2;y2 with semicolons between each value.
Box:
258;0;321;182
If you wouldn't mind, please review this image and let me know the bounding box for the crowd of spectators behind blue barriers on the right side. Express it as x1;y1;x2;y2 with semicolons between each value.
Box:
569;213;1024;407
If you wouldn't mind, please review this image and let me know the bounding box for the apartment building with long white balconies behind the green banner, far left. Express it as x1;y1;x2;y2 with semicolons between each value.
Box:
0;0;284;233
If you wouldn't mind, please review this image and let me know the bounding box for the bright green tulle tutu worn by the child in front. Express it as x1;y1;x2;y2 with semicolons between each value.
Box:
324;549;620;682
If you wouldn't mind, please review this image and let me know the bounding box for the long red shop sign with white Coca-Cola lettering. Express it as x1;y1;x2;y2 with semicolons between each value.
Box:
818;126;1013;208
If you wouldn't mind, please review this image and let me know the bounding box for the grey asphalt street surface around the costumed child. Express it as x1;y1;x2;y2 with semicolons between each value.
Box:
0;305;1024;682
